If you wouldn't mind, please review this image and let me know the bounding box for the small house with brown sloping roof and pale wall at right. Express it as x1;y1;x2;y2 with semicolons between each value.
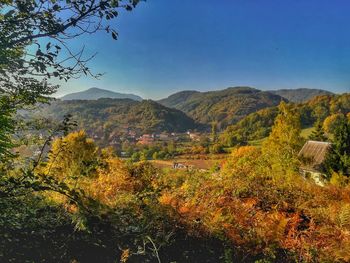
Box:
299;141;332;186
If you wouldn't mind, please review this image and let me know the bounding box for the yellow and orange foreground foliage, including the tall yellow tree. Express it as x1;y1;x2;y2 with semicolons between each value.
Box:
7;103;350;262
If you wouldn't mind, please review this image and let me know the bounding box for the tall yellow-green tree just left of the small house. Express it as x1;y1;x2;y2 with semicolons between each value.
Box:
263;102;302;174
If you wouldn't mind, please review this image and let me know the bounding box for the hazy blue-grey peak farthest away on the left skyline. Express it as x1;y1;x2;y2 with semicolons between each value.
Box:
60;88;142;101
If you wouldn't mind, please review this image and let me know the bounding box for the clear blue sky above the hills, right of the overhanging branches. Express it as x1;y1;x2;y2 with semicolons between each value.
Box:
53;0;350;99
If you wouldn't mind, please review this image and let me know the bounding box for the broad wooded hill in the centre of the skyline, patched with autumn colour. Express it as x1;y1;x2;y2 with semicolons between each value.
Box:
158;87;285;128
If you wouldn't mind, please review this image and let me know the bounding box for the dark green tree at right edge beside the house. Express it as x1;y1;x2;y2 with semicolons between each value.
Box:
325;119;350;176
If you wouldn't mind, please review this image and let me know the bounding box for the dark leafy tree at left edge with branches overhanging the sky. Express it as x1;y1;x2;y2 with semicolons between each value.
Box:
0;0;139;160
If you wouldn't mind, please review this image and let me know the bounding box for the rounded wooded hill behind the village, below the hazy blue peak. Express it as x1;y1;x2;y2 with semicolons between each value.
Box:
32;99;199;140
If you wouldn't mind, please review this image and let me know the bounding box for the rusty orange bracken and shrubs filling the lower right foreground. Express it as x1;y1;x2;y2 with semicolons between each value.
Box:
159;146;350;262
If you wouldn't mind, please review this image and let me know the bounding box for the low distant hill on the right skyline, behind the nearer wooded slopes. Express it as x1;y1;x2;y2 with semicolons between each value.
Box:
269;89;333;103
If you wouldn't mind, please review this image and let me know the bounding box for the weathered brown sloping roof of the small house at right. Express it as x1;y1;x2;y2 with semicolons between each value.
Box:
299;141;332;171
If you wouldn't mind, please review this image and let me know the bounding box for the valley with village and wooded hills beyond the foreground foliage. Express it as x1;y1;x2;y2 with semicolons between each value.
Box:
22;87;350;170
